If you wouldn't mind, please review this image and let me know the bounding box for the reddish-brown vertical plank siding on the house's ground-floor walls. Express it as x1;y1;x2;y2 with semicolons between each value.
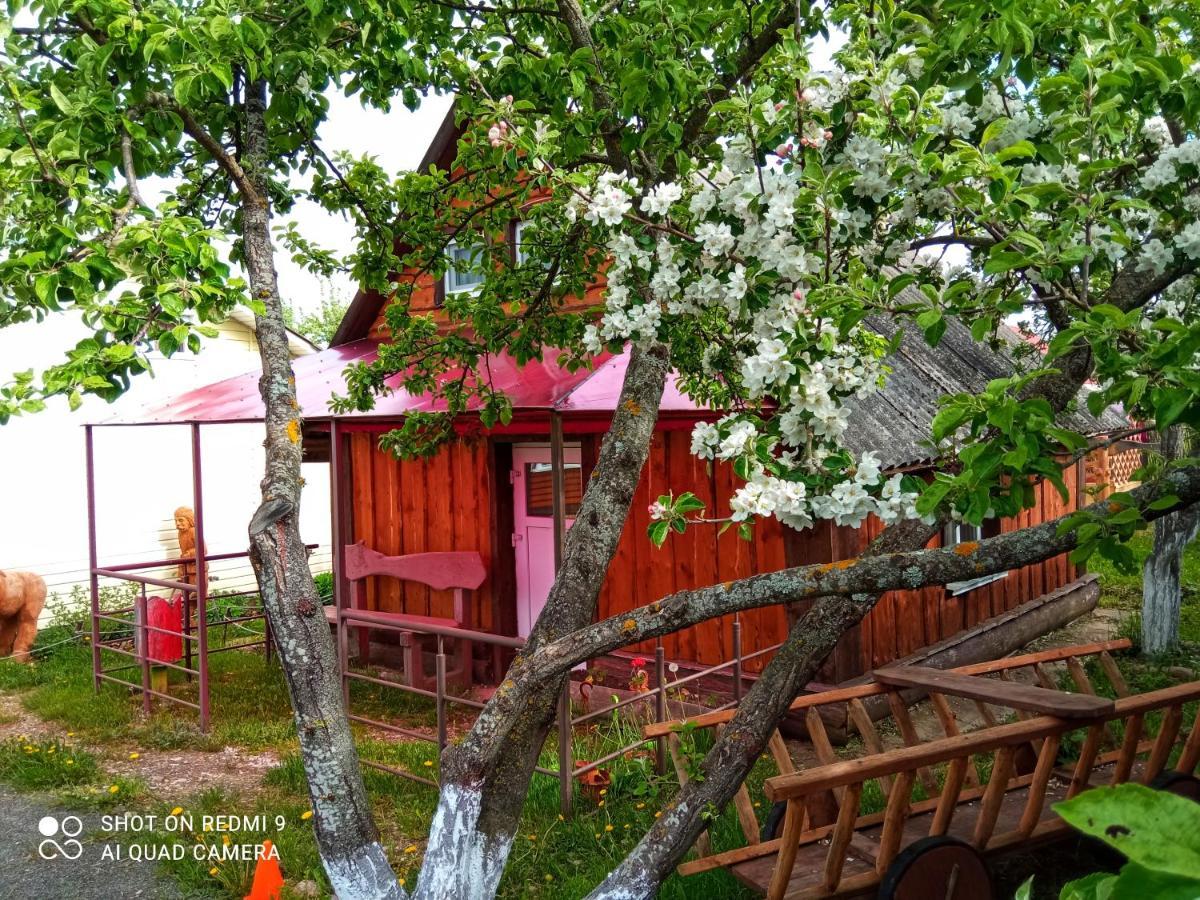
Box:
350;430;1089;682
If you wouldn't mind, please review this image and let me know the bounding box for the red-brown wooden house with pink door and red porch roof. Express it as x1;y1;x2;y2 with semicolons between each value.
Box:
129;109;1124;680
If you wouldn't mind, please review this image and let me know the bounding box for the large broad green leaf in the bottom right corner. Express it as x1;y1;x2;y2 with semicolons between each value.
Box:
1054;784;1200;877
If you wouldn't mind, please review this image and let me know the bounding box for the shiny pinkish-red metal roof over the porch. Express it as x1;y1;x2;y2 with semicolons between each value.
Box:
102;338;701;425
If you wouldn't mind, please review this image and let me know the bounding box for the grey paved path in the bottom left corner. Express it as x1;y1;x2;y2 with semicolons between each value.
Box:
0;785;182;900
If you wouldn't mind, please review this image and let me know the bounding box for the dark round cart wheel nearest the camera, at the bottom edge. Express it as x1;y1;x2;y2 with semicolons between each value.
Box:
878;836;995;900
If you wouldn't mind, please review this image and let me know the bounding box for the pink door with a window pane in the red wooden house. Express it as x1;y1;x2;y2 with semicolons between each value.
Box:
512;446;583;637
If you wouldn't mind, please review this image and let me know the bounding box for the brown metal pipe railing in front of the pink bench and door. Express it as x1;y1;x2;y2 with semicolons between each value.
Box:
337;607;782;815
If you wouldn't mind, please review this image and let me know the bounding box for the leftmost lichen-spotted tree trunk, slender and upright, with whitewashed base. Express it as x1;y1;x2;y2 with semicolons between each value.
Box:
241;83;403;900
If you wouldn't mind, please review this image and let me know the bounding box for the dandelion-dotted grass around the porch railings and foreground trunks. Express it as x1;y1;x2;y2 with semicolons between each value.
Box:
0;628;775;900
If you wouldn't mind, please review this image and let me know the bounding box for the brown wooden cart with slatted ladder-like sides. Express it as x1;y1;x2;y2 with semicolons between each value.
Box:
646;641;1200;900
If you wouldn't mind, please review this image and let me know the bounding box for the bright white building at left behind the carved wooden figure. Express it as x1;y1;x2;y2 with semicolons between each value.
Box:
0;310;329;618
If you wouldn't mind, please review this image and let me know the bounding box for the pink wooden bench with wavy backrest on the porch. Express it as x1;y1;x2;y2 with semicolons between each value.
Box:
325;541;487;690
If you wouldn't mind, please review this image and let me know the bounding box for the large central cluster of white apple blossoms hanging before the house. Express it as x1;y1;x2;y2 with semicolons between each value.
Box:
568;125;917;528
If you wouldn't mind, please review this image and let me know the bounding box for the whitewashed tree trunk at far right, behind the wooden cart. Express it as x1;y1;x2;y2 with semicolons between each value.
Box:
1141;425;1200;654
